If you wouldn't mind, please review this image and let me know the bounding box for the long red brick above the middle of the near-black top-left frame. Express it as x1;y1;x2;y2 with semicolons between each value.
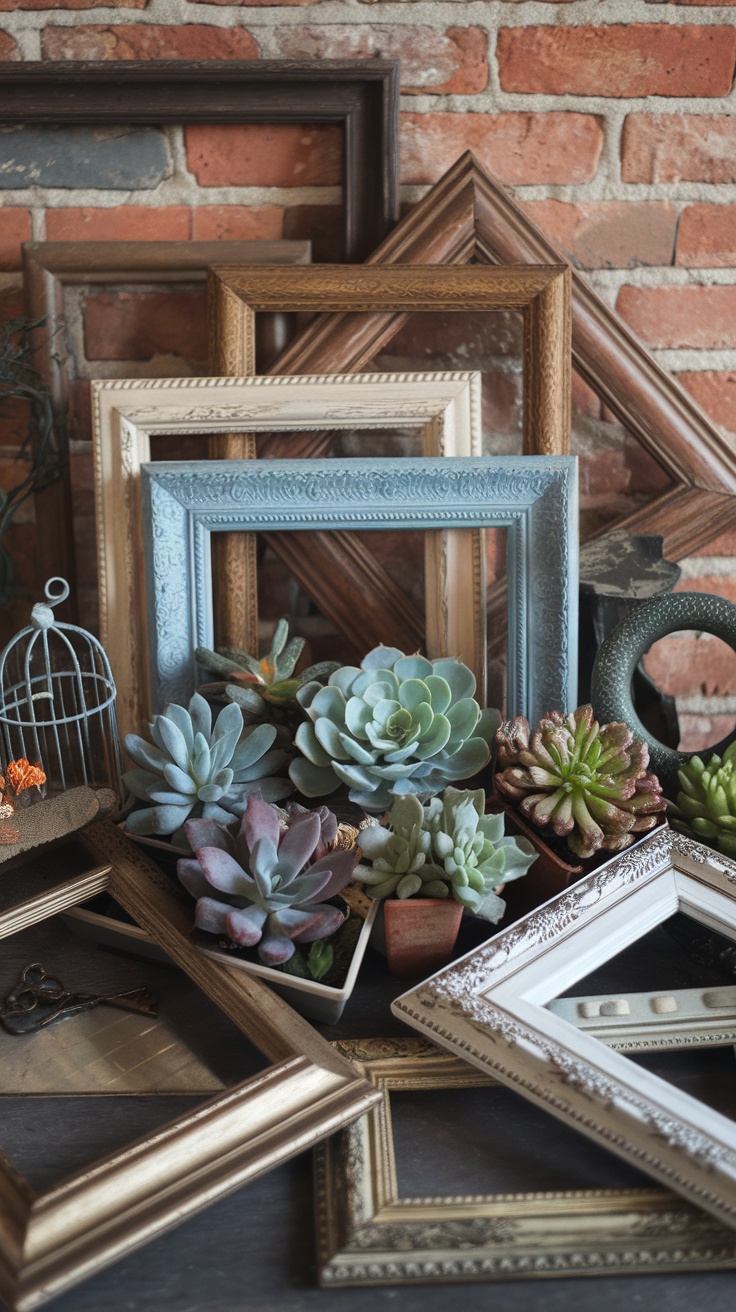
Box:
40;23;260;59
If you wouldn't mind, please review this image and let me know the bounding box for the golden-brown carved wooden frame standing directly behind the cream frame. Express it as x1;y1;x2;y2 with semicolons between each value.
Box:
209;264;571;651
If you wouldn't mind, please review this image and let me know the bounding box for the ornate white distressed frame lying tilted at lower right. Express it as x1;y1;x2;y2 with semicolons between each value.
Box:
391;828;736;1227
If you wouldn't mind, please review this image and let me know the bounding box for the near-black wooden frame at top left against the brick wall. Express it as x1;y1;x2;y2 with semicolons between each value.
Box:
0;59;399;614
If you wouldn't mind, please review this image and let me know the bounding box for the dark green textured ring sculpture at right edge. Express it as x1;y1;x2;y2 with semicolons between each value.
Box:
592;592;736;794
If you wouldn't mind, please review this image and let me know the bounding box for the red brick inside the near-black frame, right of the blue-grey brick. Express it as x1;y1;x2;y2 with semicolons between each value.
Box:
184;123;342;186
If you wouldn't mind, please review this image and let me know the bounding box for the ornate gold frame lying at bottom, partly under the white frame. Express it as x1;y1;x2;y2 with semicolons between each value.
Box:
315;1038;736;1287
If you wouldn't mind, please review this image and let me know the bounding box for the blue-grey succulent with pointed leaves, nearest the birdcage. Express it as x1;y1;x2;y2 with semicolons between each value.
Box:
123;693;294;844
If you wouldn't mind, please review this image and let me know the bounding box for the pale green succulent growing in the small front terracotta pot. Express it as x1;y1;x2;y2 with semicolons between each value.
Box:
356;787;537;922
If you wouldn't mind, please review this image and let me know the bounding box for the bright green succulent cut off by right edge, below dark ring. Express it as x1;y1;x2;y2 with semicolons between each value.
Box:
668;743;736;858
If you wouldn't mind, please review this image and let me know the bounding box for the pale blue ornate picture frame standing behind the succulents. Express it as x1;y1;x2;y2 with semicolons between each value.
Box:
142;455;579;720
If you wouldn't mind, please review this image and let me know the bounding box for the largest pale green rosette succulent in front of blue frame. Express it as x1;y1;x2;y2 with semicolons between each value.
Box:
289;647;499;812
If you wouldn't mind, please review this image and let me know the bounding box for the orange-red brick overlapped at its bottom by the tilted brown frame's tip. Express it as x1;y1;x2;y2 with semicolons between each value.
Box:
401;110;603;185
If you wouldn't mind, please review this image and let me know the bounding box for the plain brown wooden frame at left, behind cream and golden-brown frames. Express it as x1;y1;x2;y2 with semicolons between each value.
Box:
22;241;311;621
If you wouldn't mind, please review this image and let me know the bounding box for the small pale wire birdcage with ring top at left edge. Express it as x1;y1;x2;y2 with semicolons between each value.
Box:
0;579;123;802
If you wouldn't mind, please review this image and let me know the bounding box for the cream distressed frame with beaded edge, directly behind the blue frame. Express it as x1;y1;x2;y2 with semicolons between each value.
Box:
92;373;485;735
